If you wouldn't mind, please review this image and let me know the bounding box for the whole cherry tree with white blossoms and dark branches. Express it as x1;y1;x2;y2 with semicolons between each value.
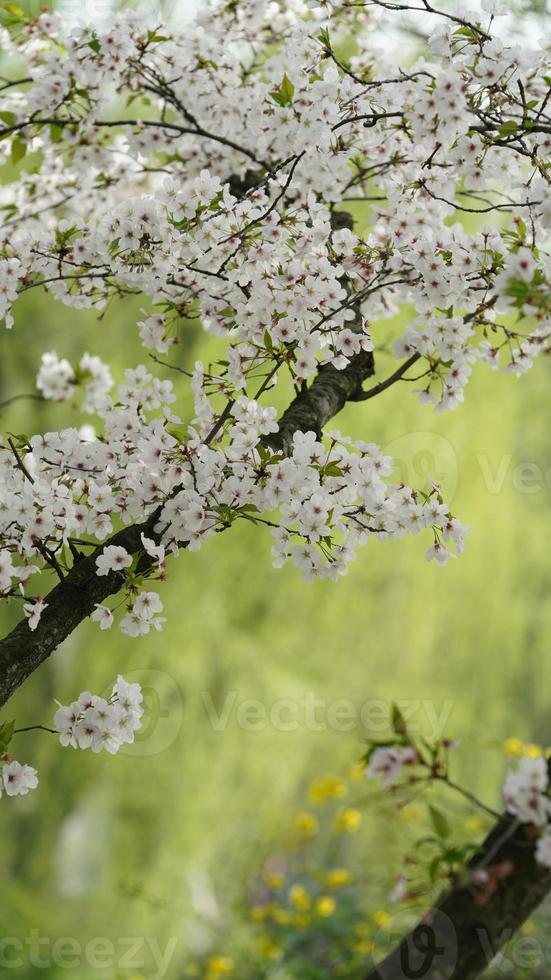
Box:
0;0;551;978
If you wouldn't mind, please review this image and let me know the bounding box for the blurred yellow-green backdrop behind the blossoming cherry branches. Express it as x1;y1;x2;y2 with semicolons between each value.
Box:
0;0;551;980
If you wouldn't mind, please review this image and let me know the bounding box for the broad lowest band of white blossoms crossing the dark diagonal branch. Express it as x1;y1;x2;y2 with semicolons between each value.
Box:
0;358;466;636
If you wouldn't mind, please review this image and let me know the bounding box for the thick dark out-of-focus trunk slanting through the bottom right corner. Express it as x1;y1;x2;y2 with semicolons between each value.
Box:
365;816;551;980
